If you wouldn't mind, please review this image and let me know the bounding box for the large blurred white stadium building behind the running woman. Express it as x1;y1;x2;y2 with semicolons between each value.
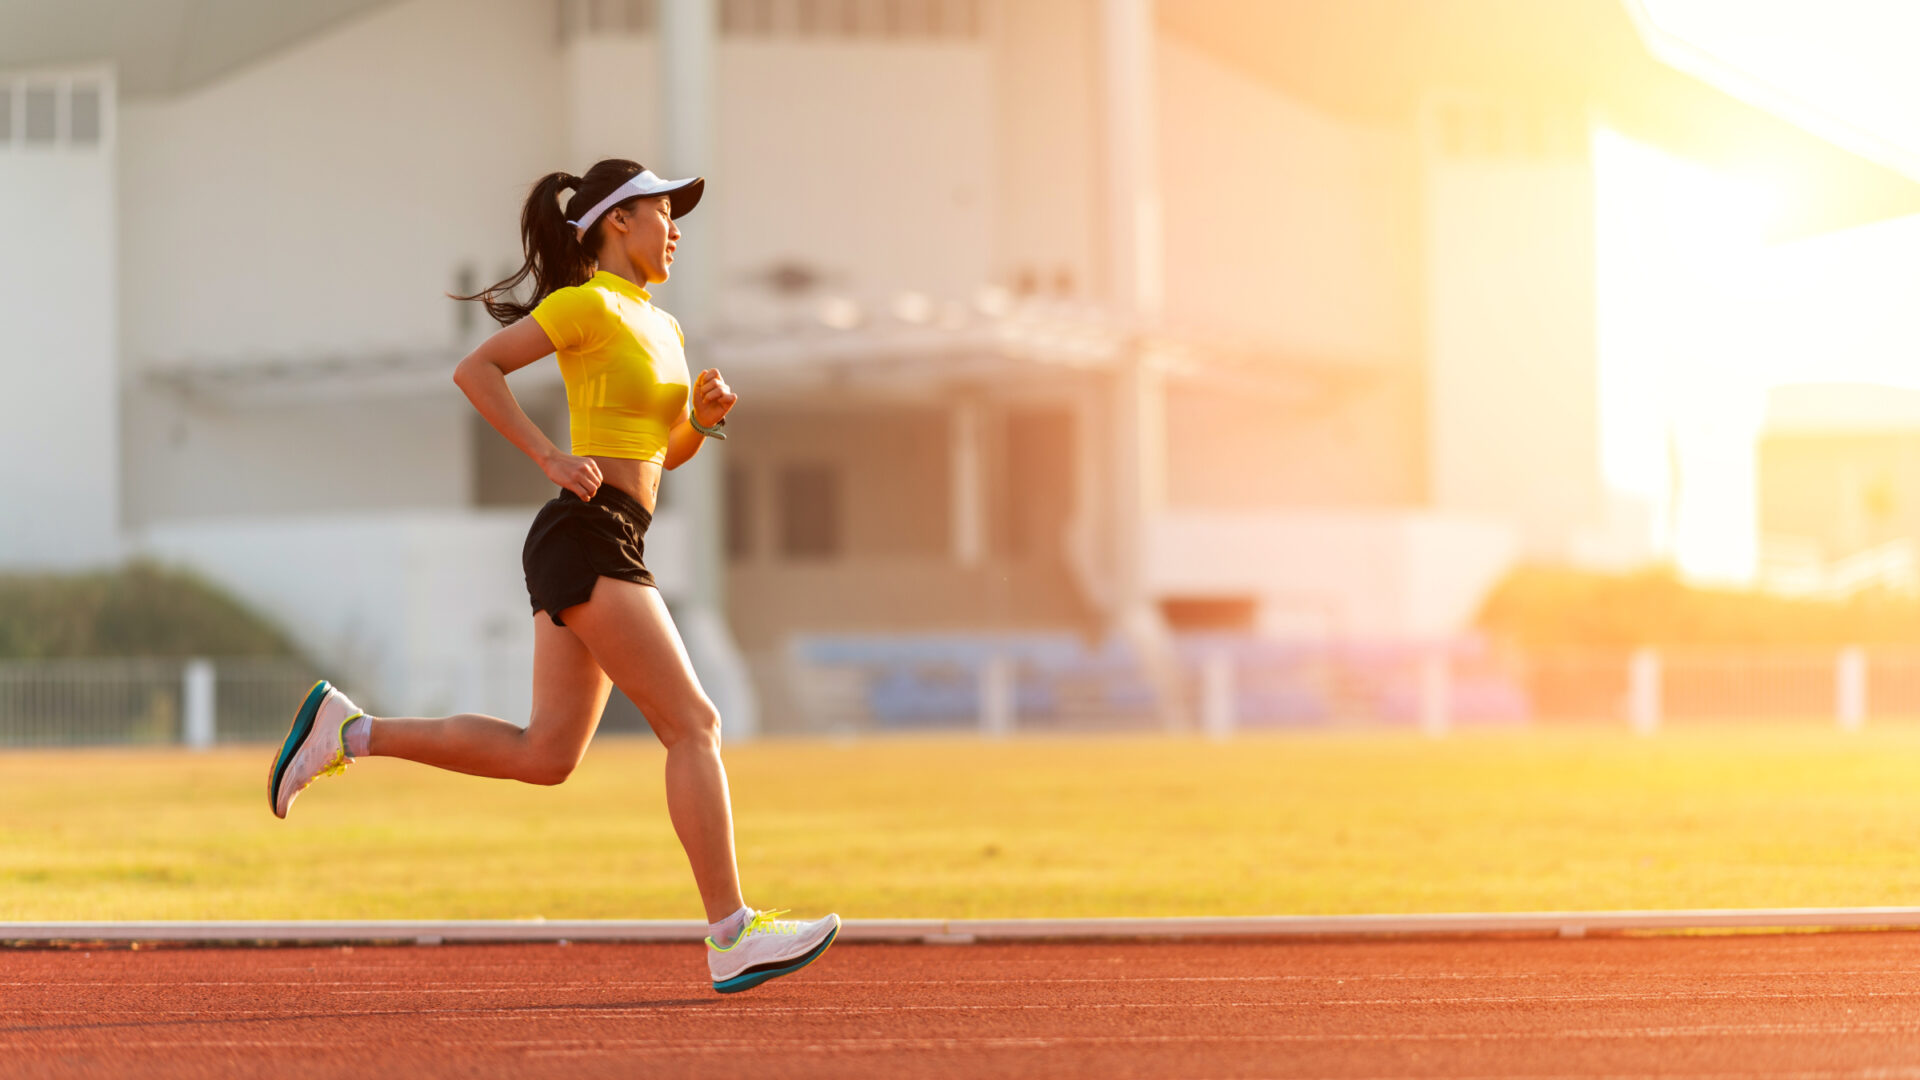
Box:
0;0;1920;730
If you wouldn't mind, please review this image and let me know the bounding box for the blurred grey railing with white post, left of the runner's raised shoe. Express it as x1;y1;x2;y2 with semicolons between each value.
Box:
0;657;319;748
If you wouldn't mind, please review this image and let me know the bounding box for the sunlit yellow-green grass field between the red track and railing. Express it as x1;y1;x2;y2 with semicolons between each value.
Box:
0;726;1920;920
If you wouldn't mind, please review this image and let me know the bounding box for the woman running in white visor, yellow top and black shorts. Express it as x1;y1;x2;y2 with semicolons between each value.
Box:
267;160;839;994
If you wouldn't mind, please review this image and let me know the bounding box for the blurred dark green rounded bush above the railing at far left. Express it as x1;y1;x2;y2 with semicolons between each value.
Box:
0;561;298;659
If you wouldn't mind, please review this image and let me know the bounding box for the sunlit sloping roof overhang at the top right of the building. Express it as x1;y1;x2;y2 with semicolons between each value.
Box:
1158;0;1920;238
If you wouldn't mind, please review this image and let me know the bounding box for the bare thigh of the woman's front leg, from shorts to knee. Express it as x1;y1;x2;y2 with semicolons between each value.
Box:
563;577;718;746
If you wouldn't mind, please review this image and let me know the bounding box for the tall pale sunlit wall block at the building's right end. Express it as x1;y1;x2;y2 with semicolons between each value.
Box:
1413;94;1597;561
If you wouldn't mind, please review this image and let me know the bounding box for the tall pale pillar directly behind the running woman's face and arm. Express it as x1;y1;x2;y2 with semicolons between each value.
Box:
655;0;760;738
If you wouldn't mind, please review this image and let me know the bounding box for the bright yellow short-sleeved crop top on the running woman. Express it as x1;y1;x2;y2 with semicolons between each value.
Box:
534;271;693;461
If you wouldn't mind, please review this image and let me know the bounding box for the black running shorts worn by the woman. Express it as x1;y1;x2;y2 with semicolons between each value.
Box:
520;484;653;626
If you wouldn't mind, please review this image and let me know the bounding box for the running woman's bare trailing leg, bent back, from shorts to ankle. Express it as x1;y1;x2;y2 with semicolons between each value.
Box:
367;611;612;784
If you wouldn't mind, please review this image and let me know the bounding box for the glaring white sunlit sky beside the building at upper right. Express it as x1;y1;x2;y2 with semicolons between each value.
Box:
1594;0;1920;580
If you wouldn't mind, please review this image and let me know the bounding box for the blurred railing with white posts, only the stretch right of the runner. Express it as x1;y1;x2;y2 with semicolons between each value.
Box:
781;636;1920;736
